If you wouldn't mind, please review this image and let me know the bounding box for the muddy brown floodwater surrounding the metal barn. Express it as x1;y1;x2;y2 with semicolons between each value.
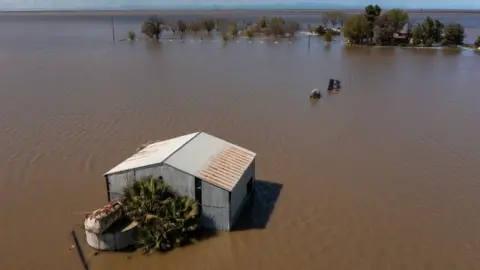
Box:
0;13;480;270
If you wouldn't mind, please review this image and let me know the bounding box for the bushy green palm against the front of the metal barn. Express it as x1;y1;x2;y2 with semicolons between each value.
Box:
122;178;199;252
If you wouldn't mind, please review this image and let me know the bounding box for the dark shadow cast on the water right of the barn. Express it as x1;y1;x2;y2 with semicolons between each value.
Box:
232;179;283;231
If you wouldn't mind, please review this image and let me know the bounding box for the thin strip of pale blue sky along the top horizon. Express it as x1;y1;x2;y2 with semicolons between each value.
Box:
0;0;480;10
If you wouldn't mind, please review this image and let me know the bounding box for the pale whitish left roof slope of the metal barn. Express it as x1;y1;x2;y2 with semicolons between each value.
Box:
105;132;199;174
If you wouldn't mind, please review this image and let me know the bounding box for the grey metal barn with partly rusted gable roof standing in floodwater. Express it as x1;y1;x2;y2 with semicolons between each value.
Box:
105;132;256;231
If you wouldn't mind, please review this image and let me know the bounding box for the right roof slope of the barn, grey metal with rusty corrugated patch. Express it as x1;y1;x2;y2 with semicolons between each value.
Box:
164;132;256;191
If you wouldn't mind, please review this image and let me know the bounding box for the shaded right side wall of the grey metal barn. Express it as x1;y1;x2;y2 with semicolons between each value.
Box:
229;159;255;226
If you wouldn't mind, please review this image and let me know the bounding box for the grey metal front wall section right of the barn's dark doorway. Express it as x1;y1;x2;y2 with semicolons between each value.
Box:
200;181;230;230
